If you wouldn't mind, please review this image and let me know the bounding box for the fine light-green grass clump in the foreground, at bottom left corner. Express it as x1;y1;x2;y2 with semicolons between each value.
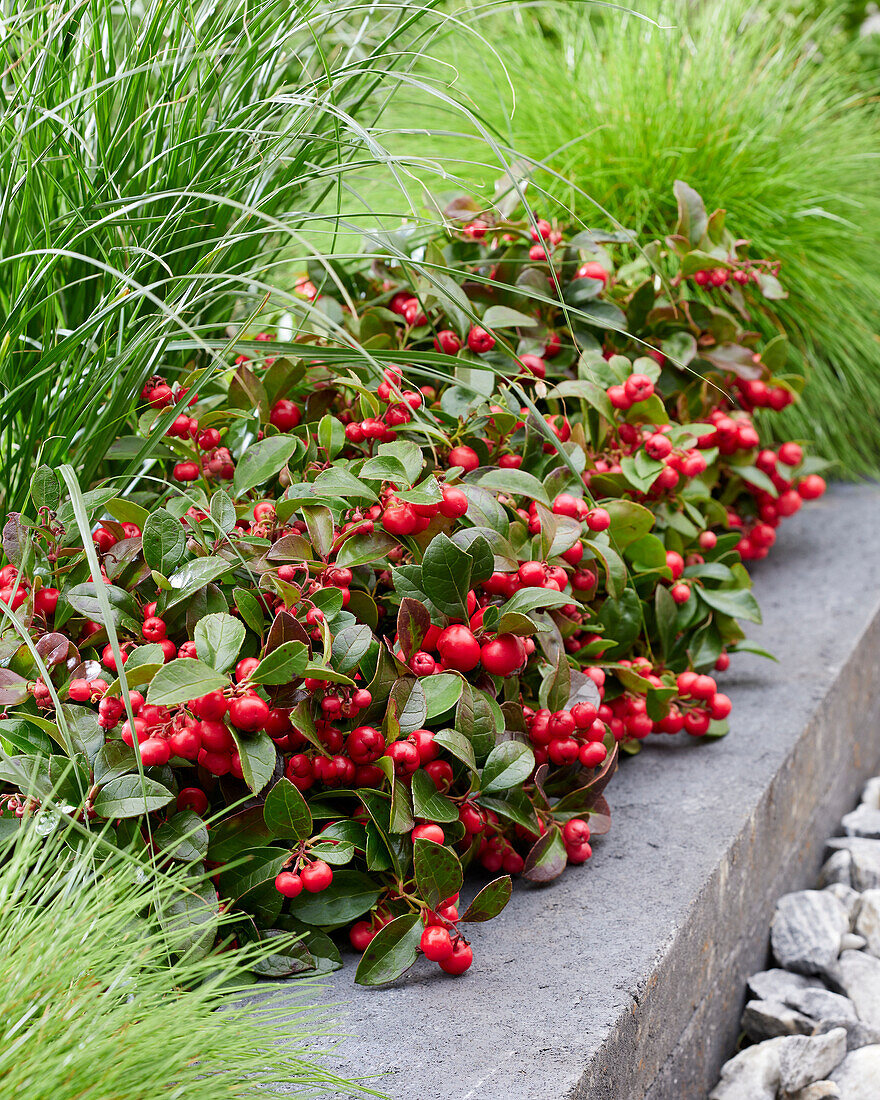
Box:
0;814;362;1100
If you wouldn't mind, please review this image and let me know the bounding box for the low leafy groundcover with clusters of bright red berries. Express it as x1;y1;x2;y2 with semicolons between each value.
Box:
0;184;825;985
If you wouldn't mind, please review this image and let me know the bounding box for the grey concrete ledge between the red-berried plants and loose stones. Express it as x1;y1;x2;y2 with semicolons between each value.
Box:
277;486;880;1100
